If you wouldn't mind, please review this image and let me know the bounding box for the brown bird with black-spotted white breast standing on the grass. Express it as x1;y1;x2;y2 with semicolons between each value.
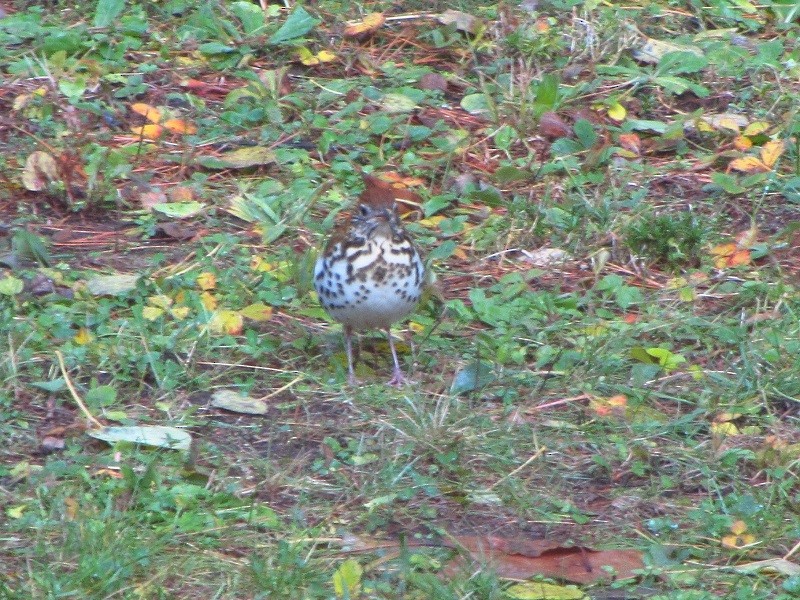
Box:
314;174;426;387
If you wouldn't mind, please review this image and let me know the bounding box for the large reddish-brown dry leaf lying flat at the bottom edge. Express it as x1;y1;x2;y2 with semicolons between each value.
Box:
445;536;644;584
